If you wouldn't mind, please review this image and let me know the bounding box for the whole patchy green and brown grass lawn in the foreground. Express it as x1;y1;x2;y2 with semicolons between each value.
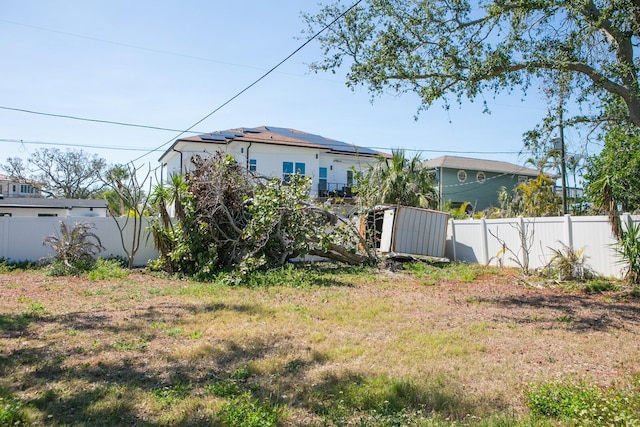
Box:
0;264;640;426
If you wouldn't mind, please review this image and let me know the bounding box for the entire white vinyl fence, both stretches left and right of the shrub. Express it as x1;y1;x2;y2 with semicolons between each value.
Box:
0;214;640;277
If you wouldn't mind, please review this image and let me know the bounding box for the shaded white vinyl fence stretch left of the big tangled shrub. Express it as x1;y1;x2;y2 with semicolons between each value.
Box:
0;216;158;266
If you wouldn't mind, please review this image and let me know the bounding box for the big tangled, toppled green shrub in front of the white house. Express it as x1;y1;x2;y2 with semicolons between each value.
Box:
151;153;375;280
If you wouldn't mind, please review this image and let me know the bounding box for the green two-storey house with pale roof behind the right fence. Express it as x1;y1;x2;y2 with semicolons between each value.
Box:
425;156;553;211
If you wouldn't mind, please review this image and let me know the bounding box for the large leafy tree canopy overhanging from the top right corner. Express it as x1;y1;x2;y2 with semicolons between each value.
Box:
305;0;640;126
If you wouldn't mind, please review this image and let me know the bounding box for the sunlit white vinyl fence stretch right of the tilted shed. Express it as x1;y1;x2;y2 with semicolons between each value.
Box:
445;214;640;277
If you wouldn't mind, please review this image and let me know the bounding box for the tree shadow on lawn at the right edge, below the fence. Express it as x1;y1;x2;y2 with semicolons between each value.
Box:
479;294;640;332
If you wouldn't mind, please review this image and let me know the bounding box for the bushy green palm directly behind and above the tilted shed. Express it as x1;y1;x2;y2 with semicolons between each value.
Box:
357;150;437;208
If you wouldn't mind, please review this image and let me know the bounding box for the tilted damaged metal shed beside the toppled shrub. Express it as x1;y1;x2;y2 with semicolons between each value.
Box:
360;205;449;258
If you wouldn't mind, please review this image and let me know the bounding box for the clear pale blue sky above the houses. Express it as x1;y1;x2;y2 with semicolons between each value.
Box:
0;0;592;177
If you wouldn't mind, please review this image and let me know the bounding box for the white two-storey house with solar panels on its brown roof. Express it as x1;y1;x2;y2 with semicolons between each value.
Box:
159;126;387;198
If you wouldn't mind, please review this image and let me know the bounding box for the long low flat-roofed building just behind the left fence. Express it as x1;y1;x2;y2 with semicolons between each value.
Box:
0;197;107;217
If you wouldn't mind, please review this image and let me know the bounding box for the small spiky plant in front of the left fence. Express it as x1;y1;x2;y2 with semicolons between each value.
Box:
42;221;104;273
